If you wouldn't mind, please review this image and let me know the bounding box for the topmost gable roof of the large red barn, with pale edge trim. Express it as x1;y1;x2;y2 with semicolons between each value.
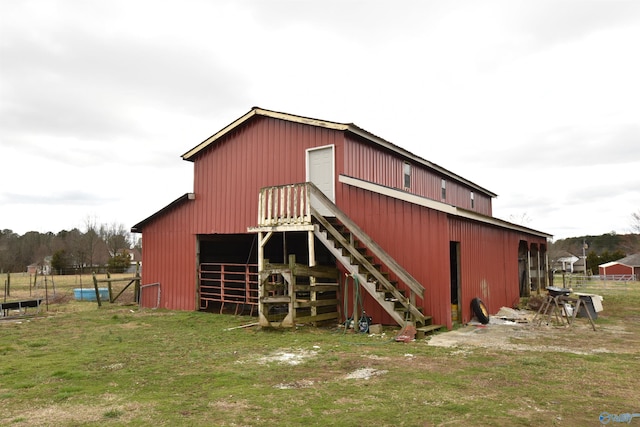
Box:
181;107;497;197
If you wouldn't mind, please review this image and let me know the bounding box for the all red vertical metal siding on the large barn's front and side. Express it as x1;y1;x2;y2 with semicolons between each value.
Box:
142;112;544;326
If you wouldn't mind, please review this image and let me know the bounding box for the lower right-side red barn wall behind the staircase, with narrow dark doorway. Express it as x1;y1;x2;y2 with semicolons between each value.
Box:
337;184;546;327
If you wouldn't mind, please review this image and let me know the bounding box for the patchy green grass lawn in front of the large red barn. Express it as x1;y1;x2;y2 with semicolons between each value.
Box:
0;275;640;426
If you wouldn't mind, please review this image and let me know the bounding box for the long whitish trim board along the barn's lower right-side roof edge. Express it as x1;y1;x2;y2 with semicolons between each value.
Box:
338;175;552;238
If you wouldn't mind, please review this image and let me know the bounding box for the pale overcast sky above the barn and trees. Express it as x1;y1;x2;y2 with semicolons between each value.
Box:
0;0;640;239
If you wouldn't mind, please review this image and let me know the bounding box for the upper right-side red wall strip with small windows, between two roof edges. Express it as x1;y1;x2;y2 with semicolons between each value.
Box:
343;136;491;215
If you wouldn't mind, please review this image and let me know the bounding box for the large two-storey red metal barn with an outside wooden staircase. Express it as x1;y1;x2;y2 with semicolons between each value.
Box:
132;108;551;328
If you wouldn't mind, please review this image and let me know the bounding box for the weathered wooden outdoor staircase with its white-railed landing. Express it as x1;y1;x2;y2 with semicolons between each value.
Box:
250;182;442;335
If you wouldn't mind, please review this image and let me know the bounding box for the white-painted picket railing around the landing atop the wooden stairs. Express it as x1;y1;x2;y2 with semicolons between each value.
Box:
258;182;311;227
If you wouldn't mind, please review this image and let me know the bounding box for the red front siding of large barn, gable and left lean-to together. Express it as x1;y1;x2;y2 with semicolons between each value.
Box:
142;117;343;310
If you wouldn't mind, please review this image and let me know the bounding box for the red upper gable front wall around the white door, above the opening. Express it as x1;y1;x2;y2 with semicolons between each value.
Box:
193;117;343;234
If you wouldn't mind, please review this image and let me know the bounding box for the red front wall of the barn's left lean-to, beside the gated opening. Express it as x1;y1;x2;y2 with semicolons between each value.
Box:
142;201;196;310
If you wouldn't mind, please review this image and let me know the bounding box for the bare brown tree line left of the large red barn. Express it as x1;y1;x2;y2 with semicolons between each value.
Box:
0;220;141;274
